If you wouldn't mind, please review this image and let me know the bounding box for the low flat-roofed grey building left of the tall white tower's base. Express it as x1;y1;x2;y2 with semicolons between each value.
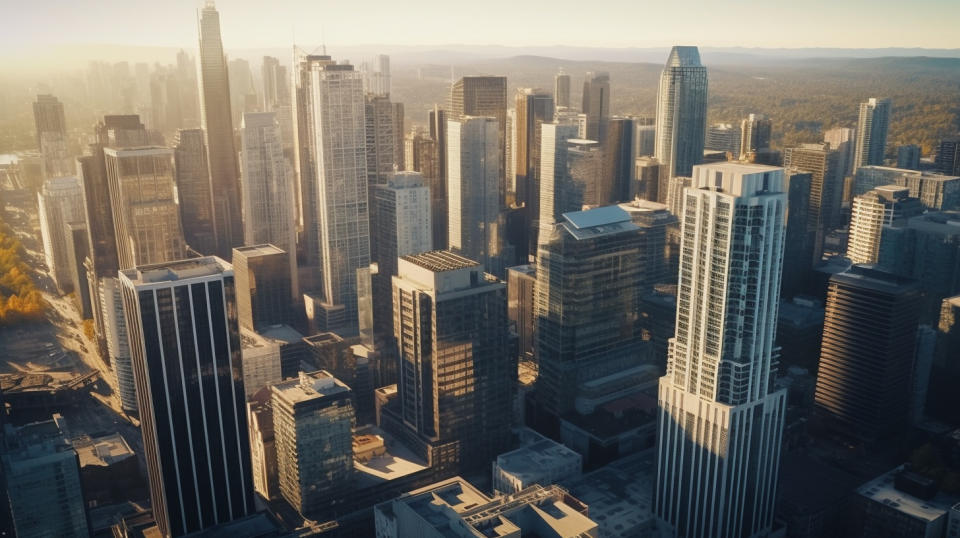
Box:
493;431;583;495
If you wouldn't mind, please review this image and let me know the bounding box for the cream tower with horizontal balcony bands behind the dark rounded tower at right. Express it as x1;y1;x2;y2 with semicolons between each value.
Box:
847;185;923;264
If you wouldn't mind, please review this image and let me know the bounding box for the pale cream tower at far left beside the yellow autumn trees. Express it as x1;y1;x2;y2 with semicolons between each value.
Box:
37;177;86;293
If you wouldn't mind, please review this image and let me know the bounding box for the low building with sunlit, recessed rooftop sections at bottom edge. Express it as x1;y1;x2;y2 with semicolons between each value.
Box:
374;476;600;538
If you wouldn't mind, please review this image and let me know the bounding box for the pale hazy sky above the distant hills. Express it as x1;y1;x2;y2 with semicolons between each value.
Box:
0;0;960;53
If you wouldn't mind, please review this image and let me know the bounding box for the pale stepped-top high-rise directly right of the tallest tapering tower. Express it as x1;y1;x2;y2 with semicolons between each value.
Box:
240;112;300;301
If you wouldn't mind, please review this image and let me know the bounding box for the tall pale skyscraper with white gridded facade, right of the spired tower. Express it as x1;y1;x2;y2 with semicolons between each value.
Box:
296;53;370;335
